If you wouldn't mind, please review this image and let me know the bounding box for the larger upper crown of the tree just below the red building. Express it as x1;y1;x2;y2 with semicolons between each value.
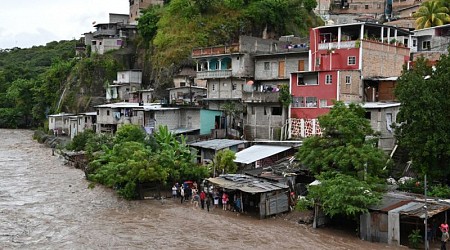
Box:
296;102;386;178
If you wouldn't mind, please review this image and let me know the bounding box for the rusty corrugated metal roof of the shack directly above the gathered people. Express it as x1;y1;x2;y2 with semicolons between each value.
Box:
208;174;288;194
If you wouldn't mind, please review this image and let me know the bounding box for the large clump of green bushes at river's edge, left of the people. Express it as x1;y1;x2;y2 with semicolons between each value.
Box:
86;125;208;199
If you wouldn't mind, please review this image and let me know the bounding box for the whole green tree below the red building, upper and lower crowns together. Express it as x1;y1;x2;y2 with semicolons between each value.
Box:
296;102;386;218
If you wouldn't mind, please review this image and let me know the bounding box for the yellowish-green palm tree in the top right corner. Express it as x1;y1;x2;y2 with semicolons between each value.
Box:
413;0;450;29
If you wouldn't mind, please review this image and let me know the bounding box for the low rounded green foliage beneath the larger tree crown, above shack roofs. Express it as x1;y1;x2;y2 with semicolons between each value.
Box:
308;174;381;218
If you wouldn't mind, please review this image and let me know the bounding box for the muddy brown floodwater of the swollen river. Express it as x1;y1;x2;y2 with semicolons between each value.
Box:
0;129;408;250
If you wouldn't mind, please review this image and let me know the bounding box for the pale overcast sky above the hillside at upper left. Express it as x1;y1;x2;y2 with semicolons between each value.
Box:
0;0;129;49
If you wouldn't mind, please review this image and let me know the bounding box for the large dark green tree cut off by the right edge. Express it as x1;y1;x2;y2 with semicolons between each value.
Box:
395;55;450;180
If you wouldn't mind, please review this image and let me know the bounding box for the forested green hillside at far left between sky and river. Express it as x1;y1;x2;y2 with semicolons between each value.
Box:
0;41;75;128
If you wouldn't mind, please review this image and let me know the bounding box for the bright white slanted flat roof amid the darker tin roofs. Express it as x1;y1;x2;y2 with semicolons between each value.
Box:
234;145;291;164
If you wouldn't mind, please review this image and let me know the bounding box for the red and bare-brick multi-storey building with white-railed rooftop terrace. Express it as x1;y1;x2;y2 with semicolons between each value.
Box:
290;23;411;119
